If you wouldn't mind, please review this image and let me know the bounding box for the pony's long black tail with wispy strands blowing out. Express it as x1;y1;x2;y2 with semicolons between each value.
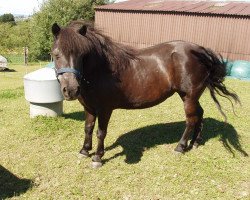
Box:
192;48;240;121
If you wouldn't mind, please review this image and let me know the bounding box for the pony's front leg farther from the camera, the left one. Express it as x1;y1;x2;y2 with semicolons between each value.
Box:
80;109;96;157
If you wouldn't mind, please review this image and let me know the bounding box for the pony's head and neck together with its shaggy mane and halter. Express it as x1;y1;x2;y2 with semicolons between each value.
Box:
52;20;137;100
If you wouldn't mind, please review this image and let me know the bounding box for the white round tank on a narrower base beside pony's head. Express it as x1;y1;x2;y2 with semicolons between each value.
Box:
24;68;63;117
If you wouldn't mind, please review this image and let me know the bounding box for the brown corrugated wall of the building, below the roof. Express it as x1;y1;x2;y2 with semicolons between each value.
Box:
95;10;250;60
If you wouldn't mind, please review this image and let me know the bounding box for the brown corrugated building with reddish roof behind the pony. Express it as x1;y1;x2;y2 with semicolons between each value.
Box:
95;0;250;61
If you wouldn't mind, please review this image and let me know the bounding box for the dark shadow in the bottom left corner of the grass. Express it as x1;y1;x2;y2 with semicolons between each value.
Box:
0;165;32;199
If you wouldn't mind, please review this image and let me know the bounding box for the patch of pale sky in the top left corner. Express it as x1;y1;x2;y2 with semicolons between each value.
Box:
0;0;43;15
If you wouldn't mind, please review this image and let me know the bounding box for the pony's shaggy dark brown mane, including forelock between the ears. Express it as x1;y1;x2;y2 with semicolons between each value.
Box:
59;21;138;72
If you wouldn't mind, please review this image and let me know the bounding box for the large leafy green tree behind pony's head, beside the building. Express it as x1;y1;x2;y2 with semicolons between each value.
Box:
29;0;106;60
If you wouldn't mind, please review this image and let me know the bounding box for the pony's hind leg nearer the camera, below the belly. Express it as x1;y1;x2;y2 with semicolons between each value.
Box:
175;96;202;153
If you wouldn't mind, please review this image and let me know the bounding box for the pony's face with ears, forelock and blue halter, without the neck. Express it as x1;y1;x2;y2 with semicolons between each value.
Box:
52;23;87;100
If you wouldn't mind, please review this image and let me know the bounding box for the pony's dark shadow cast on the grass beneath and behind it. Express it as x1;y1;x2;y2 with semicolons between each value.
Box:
104;118;248;164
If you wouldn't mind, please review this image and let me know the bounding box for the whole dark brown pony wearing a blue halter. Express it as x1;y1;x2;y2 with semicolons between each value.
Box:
52;21;239;167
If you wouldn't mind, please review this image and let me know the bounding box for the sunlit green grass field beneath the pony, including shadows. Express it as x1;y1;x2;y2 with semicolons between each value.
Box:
0;65;250;200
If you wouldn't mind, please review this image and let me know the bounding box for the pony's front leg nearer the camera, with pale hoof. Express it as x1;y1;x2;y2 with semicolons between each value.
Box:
92;110;112;168
